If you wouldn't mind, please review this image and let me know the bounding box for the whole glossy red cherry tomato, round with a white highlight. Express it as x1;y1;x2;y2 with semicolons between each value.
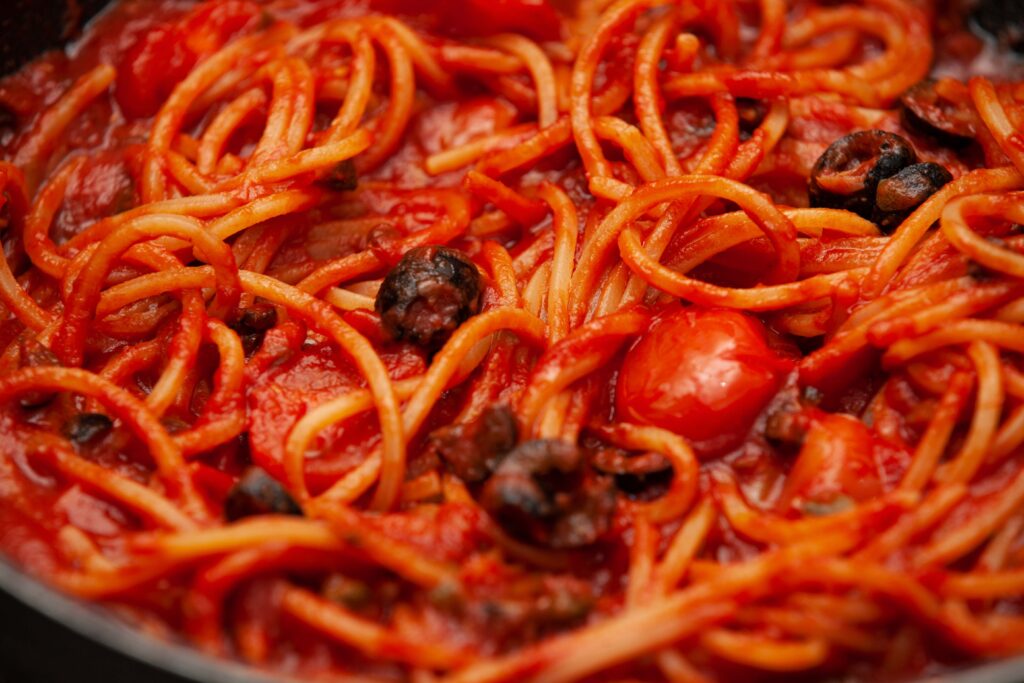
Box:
615;307;794;456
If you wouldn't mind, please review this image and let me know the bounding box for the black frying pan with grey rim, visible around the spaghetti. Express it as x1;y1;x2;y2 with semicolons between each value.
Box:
0;0;1024;683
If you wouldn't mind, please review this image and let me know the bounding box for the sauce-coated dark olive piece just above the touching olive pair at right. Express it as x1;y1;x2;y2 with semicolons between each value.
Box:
899;79;978;146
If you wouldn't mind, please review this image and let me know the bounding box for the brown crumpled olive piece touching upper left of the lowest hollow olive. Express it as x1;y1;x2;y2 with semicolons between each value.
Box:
429;403;519;483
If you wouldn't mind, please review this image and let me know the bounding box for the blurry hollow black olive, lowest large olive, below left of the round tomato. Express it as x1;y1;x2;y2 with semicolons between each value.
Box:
480;439;615;549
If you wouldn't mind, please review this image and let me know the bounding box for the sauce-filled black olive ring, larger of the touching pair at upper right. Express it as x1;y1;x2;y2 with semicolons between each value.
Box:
808;130;918;219
